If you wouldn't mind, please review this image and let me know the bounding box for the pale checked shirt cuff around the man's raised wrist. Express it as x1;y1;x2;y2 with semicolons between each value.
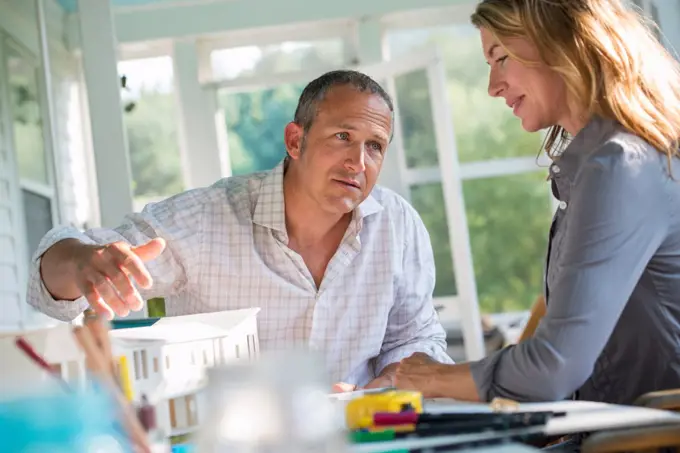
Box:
26;227;96;322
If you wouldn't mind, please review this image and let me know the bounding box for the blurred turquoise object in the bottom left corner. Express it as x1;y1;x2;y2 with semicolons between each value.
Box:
0;391;133;453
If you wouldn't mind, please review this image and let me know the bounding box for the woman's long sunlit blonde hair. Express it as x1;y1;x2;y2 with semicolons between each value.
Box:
471;0;680;163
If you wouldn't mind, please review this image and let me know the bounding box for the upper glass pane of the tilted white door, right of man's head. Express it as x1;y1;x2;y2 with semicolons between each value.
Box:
394;69;439;168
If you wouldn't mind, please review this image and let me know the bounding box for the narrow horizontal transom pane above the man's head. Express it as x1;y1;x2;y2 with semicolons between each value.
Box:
210;38;346;79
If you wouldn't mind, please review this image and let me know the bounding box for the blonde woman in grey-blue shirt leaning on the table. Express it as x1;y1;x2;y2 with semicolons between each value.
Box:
395;0;680;404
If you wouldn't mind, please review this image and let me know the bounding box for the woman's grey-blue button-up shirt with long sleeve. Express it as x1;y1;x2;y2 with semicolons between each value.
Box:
471;118;680;404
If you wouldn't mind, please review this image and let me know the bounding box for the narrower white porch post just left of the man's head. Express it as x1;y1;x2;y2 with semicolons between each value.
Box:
173;41;226;188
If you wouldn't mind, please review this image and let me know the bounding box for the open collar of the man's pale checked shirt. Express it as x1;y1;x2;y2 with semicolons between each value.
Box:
253;159;384;234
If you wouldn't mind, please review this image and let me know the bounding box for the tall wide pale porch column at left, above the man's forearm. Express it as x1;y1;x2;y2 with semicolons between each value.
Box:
78;0;133;227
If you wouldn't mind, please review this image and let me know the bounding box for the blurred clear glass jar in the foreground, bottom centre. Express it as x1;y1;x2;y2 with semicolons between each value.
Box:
198;352;348;453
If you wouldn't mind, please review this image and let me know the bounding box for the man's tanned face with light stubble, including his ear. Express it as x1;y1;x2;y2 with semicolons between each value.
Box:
285;86;392;214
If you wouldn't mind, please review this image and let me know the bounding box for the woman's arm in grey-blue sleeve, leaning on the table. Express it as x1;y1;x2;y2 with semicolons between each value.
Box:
396;142;669;401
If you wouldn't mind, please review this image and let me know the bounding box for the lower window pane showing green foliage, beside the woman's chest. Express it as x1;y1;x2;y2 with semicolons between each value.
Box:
463;172;552;313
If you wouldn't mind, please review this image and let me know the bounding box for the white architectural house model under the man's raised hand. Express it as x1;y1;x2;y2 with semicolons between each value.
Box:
111;308;260;437
